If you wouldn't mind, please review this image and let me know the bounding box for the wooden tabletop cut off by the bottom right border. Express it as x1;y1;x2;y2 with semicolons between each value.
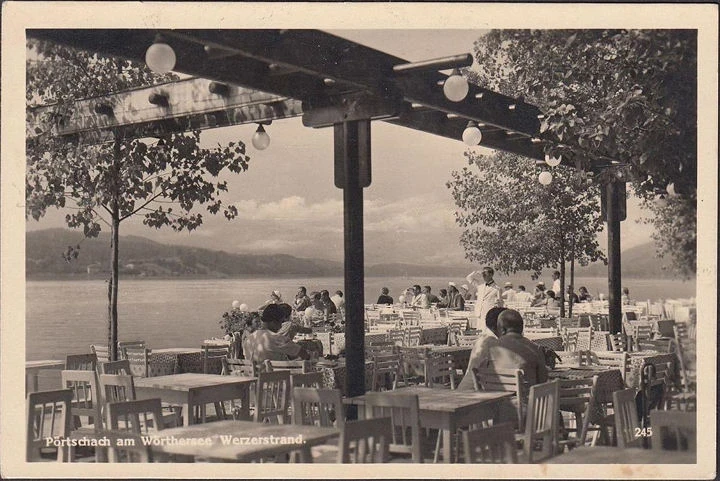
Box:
544;446;697;464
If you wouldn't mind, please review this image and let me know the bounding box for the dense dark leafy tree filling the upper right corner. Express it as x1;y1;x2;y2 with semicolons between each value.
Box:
467;30;697;275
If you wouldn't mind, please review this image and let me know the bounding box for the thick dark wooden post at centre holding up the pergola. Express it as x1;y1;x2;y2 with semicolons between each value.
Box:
334;120;370;419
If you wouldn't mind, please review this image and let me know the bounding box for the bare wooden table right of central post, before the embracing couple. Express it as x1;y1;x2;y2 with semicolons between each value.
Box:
345;386;514;463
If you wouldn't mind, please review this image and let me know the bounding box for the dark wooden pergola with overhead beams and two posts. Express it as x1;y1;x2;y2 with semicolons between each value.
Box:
27;29;624;404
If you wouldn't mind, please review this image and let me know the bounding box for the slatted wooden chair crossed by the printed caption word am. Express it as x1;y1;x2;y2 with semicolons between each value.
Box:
107;398;163;463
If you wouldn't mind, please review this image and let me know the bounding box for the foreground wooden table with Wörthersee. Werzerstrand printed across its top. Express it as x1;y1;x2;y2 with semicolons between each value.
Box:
150;421;340;463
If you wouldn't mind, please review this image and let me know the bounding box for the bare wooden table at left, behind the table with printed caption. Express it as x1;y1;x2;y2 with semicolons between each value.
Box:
135;373;257;426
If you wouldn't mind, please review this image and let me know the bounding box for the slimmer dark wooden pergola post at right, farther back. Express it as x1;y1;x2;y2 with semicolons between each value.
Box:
603;182;625;334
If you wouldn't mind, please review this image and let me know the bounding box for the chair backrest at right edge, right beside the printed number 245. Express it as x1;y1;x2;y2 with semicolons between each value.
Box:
650;410;697;451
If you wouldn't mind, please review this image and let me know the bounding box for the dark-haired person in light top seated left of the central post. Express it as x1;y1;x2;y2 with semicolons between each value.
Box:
244;304;310;363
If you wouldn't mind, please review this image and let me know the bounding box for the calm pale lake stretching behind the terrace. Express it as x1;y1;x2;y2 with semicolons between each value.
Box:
25;277;695;360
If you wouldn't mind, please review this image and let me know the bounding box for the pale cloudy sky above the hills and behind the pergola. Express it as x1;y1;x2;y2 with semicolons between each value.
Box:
27;29;651;265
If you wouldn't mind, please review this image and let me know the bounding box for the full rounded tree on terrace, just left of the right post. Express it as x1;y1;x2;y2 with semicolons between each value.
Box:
447;151;605;316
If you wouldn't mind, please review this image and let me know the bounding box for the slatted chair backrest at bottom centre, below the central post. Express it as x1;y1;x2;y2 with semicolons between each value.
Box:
338;418;393;464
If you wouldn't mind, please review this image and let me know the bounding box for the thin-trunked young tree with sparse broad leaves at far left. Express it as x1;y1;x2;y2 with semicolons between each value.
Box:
26;40;249;359
